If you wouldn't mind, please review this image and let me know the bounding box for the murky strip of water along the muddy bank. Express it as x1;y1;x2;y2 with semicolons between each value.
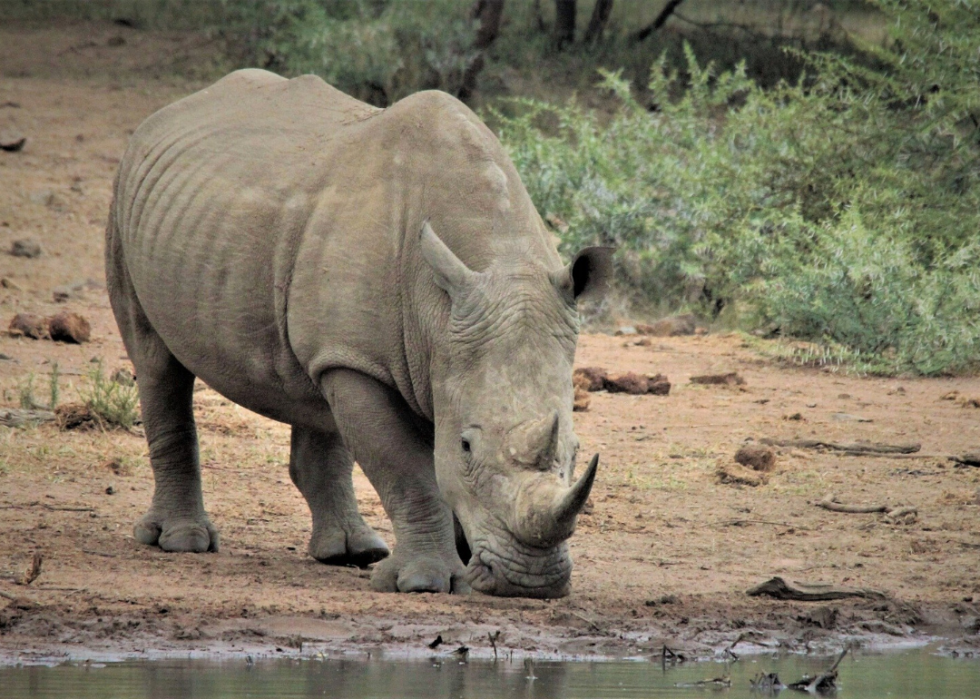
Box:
0;651;980;699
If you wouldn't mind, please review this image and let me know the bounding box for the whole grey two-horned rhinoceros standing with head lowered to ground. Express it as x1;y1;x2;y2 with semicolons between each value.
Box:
106;69;611;597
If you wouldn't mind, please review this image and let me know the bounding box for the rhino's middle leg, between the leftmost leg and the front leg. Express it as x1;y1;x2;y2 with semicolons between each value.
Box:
289;426;388;568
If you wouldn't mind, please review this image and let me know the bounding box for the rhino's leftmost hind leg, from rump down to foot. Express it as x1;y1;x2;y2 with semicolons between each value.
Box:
106;224;218;552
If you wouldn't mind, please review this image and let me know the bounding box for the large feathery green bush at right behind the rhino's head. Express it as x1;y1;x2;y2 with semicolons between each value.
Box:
489;0;980;375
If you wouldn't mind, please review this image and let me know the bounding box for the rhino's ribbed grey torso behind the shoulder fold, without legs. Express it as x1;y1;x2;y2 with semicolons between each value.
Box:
114;70;378;422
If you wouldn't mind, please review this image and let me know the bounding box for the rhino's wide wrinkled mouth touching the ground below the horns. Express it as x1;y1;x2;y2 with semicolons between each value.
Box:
464;535;572;599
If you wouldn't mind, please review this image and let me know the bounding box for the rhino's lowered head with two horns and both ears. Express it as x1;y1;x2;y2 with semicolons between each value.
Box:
421;224;611;597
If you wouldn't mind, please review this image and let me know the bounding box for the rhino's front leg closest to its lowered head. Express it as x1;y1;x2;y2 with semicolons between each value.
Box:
322;369;469;593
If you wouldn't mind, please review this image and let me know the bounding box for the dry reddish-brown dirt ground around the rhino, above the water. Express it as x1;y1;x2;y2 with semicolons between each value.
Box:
0;24;980;661
